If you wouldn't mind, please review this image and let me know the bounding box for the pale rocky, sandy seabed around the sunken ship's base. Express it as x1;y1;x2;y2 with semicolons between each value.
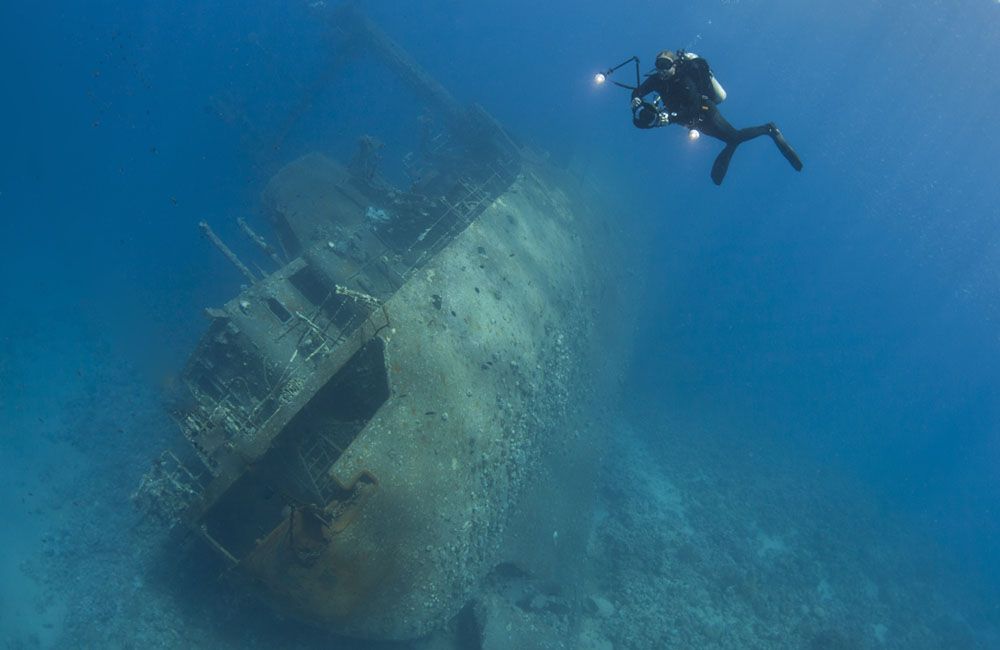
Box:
0;346;1000;650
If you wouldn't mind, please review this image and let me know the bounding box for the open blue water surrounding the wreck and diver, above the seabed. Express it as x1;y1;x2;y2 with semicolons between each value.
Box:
0;0;1000;647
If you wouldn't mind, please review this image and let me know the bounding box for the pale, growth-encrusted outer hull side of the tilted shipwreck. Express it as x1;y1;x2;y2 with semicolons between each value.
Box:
250;170;601;638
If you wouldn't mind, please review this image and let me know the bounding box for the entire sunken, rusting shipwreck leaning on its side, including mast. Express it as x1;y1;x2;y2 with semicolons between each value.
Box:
137;7;621;639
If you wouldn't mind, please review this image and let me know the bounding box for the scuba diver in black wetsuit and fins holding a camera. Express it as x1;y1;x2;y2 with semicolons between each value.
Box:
632;50;802;185
